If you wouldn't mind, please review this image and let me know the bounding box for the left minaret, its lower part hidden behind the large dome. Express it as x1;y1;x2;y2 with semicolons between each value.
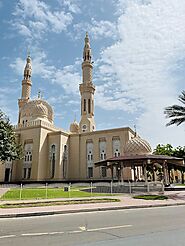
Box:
18;54;32;123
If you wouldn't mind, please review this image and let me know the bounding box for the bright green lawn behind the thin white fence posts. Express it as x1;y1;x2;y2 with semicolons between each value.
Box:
1;188;110;200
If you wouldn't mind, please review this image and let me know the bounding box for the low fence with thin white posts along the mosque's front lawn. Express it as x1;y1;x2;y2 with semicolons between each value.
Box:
0;182;164;200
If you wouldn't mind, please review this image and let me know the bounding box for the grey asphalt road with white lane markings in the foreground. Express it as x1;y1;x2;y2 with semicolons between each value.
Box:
0;206;185;246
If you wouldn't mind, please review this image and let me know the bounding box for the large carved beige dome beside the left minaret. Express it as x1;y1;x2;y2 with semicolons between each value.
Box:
20;98;53;123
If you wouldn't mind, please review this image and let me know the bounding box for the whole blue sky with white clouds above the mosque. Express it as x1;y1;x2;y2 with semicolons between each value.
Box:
0;0;185;148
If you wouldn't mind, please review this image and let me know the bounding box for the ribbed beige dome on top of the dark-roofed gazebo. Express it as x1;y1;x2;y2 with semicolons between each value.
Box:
124;136;152;155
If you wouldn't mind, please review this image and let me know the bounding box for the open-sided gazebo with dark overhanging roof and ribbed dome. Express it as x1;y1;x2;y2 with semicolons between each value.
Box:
95;136;185;185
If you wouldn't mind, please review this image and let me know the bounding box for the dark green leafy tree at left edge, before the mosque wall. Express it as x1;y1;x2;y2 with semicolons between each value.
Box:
0;110;22;162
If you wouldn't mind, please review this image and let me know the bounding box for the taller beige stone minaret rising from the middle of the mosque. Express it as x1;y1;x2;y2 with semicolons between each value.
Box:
80;33;95;132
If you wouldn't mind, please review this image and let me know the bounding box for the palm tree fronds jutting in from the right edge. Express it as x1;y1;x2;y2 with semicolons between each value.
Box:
164;91;185;126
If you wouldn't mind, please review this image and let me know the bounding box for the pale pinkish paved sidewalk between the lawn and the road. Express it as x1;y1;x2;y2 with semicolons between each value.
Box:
0;191;185;218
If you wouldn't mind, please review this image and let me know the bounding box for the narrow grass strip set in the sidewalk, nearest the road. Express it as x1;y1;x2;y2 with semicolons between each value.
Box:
0;198;120;208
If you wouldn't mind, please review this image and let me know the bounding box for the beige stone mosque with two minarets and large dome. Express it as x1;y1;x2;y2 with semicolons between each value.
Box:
0;33;155;182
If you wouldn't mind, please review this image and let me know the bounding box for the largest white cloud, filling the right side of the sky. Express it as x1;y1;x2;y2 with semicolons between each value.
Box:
96;0;185;145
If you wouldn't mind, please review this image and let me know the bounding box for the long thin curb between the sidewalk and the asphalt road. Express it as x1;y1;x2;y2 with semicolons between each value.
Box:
0;202;185;218
